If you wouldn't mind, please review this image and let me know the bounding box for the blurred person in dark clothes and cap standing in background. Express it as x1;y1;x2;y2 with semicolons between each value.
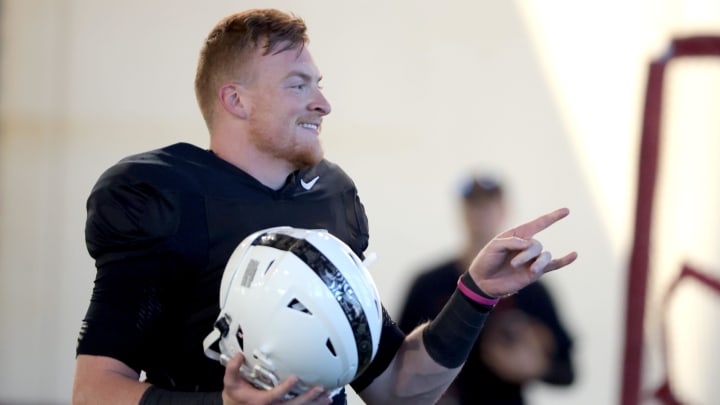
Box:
399;176;574;405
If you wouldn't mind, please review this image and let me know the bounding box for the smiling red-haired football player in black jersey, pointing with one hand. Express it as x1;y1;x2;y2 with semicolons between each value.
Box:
73;10;576;404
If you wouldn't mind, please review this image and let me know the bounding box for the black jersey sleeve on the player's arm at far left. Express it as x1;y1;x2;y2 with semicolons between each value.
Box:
77;165;179;372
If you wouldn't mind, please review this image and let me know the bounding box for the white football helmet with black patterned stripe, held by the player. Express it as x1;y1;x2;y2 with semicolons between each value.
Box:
204;227;382;397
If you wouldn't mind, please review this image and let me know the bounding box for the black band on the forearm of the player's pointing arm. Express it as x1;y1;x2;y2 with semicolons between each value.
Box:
423;290;492;368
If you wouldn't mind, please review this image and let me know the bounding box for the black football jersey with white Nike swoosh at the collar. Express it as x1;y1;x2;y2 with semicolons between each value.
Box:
77;143;404;398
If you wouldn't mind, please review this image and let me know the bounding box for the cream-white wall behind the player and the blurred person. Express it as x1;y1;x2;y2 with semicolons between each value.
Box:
0;0;720;404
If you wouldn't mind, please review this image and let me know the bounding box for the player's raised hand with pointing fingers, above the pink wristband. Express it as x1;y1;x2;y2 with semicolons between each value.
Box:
468;208;577;297
